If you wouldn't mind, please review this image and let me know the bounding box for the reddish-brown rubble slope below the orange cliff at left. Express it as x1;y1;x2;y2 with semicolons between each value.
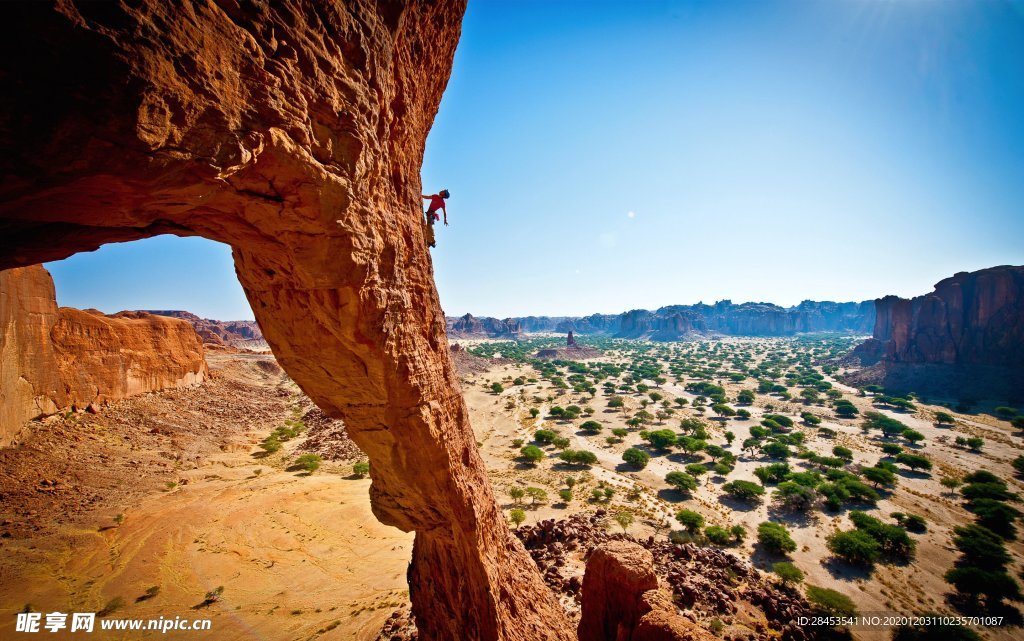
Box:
0;359;299;538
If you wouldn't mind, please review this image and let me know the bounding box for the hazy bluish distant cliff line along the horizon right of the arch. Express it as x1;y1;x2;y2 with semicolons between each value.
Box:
446;300;874;341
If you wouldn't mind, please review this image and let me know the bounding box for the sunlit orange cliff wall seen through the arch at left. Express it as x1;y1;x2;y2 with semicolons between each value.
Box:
0;265;209;445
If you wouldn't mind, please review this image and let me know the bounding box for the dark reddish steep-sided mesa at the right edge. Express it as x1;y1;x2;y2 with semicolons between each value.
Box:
846;265;1024;399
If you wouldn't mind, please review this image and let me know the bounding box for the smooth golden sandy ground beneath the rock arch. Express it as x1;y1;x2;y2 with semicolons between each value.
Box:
0;354;412;640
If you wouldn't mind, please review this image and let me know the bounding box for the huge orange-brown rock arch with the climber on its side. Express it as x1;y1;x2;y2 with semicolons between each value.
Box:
0;0;572;639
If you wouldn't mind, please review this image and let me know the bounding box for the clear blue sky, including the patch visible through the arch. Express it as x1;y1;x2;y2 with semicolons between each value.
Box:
50;0;1024;318
